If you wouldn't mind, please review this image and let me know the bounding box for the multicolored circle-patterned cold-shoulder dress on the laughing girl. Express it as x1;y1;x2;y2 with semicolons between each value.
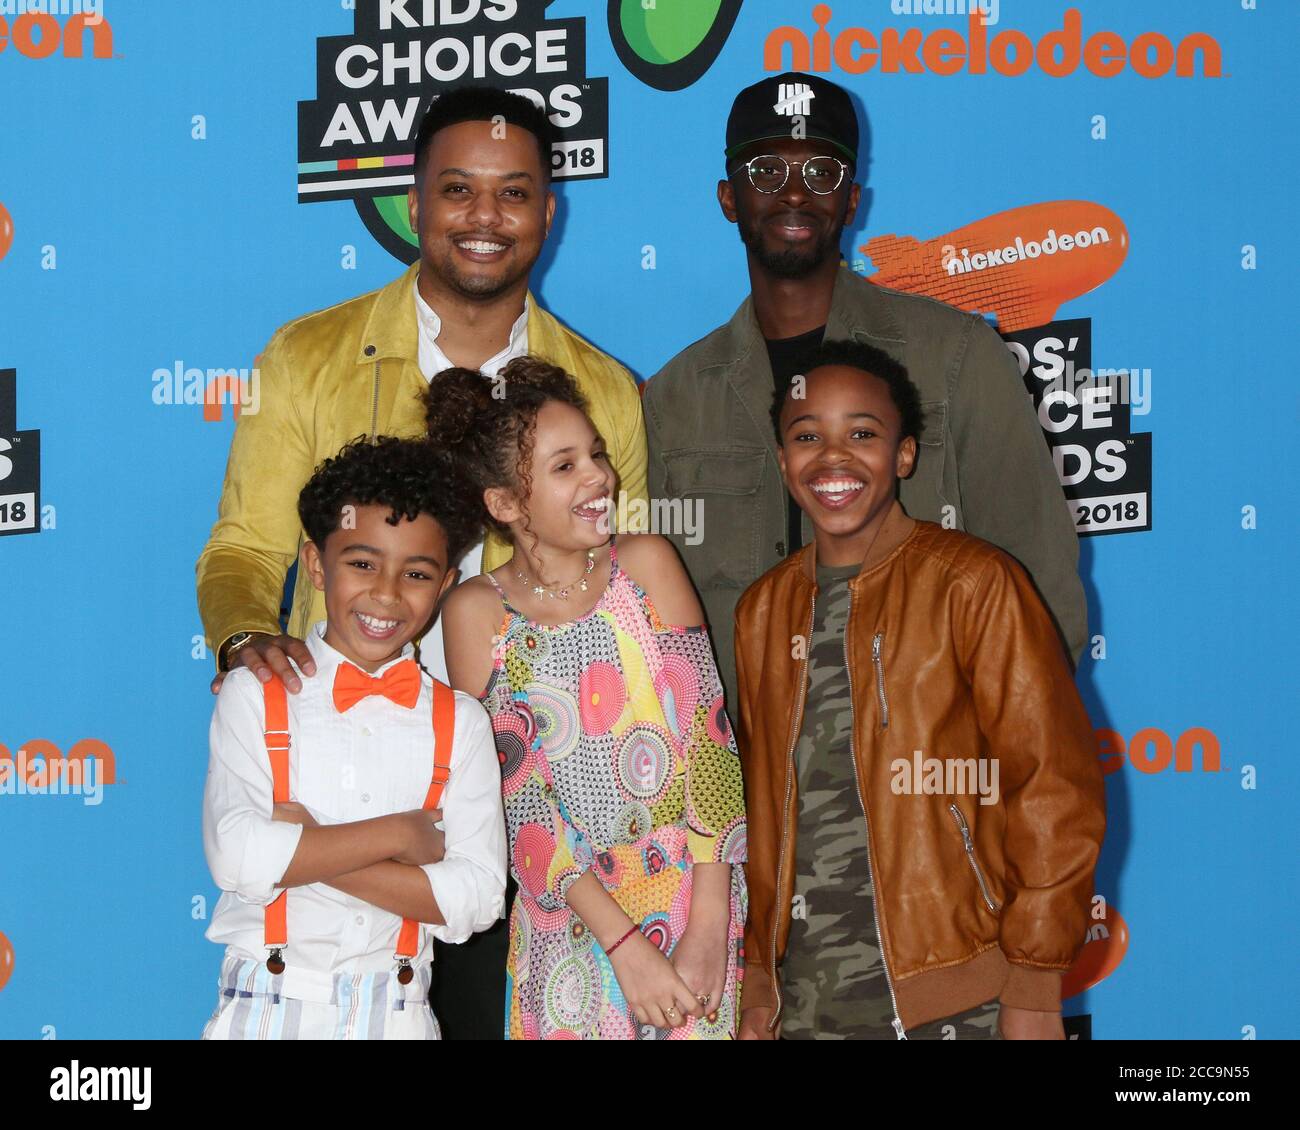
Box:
482;540;746;1039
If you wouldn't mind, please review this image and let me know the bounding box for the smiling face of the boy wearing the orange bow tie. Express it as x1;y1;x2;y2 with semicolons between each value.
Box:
303;506;456;672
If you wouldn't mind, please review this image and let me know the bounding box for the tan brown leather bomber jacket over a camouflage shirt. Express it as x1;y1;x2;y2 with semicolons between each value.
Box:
736;510;1105;1036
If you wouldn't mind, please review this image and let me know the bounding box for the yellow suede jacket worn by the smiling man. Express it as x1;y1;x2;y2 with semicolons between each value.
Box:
198;264;646;651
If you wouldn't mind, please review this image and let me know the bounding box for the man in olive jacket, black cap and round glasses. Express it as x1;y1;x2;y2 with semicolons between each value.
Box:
642;73;1087;710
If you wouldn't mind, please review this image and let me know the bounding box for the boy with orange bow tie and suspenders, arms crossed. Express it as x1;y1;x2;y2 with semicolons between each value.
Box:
203;438;506;1039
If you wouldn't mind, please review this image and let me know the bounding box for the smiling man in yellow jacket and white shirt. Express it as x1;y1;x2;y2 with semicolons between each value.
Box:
198;87;646;1038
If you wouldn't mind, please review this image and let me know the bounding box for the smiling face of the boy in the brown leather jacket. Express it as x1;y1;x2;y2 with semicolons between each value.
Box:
777;365;917;566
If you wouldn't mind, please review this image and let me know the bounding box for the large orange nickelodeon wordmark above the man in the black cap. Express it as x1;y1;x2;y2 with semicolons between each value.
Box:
763;4;1223;78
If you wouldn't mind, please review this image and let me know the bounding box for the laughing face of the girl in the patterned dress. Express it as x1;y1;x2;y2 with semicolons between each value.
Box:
486;401;616;555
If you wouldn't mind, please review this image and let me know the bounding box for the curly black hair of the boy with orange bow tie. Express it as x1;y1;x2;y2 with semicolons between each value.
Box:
298;436;482;567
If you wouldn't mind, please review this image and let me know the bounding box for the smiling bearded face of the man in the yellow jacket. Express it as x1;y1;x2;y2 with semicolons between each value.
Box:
407;122;555;299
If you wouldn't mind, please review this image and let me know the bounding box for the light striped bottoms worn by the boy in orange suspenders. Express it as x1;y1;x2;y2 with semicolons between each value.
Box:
203;954;442;1040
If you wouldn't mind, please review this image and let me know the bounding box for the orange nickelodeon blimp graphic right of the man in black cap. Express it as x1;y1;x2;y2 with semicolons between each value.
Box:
859;200;1128;333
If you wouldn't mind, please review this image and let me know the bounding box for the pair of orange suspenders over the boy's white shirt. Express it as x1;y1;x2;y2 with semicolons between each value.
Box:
263;677;456;984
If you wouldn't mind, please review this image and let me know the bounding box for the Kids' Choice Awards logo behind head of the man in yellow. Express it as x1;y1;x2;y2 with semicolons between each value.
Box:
298;0;610;263
